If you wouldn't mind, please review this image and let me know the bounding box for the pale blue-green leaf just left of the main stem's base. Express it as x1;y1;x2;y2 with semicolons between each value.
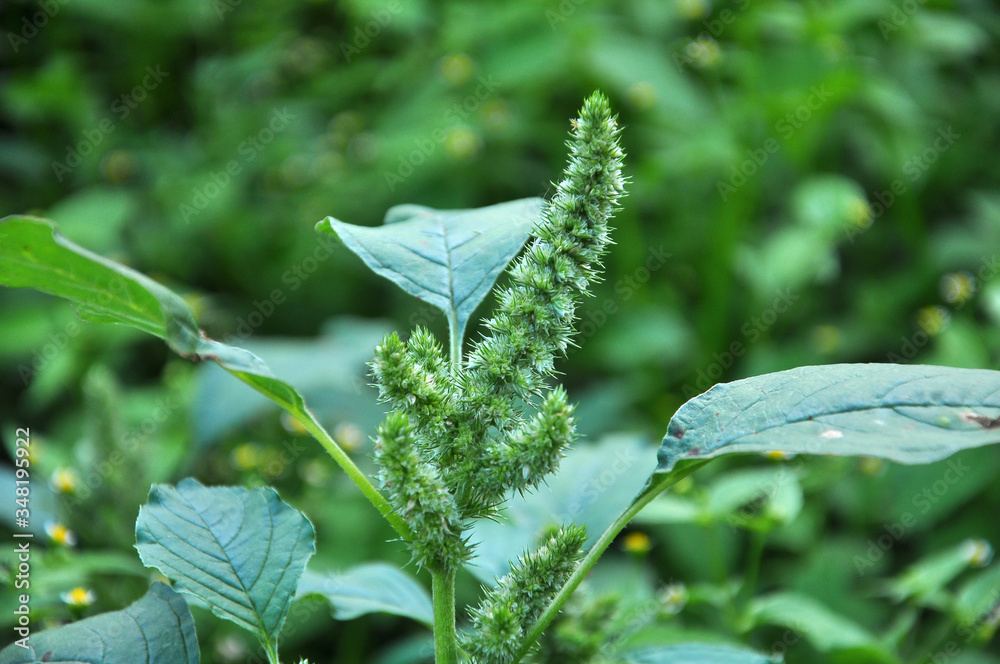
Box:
296;563;434;626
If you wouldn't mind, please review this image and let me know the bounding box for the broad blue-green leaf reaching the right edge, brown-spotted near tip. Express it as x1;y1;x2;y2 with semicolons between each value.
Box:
656;364;1000;473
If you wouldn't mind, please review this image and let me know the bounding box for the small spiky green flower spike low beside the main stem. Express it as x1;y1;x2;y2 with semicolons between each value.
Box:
463;526;587;664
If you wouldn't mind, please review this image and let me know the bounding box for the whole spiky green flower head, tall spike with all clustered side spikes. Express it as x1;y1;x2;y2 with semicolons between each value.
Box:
371;93;625;576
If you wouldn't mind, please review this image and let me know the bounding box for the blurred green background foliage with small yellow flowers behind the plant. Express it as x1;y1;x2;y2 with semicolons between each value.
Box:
0;0;1000;664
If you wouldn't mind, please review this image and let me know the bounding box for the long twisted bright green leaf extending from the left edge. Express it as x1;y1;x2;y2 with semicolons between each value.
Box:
0;217;342;464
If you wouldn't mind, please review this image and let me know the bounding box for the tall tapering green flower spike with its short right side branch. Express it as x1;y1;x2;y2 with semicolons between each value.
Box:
452;94;625;511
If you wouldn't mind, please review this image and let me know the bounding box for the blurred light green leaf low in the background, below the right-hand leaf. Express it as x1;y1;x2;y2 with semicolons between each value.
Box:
750;592;896;663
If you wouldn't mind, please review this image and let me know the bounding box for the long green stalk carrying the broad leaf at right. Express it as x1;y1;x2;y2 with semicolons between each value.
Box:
511;459;710;664
